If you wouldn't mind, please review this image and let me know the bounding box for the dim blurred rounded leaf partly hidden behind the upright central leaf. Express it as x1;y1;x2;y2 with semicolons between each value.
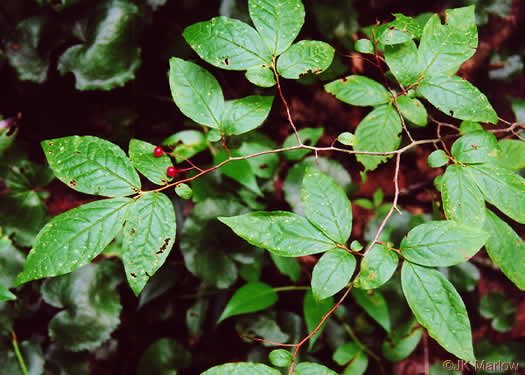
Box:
283;156;351;214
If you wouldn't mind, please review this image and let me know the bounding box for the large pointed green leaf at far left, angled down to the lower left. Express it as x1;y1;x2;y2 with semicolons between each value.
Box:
16;198;133;285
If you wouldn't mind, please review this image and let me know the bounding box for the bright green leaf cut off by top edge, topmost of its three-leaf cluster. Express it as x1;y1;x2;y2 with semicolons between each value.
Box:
248;0;304;56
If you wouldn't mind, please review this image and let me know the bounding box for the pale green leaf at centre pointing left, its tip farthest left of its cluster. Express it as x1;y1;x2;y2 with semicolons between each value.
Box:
219;211;335;257
